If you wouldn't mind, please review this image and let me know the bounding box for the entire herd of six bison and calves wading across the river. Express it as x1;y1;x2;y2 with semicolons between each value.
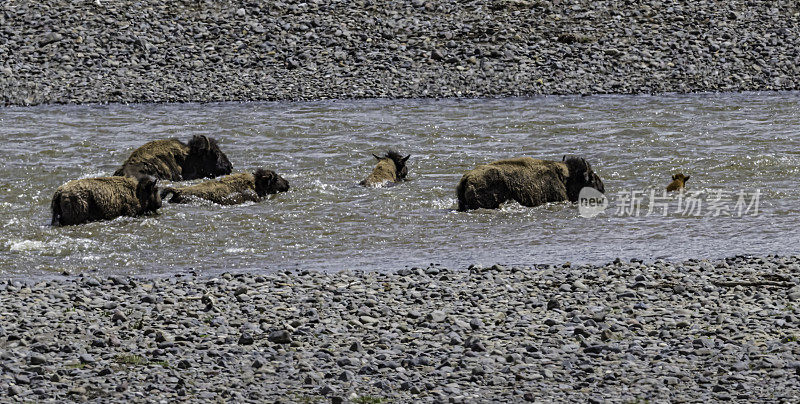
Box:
51;135;689;226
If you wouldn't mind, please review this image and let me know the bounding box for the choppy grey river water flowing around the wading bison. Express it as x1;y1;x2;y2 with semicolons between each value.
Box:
0;93;800;276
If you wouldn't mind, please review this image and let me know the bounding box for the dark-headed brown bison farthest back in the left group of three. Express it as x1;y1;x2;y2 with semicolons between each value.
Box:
114;135;233;181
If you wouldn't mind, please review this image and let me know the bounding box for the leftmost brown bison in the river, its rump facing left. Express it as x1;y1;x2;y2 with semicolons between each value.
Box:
50;176;161;226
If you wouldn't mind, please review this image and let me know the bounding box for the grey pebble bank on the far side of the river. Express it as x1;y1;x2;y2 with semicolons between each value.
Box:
0;0;800;105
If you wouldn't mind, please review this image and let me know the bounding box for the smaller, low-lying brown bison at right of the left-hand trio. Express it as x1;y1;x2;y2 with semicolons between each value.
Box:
161;168;289;205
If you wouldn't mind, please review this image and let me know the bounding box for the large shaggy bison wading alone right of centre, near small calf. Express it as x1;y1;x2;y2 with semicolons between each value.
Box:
456;156;605;212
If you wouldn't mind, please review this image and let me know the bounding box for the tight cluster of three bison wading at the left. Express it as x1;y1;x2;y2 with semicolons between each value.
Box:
50;136;289;226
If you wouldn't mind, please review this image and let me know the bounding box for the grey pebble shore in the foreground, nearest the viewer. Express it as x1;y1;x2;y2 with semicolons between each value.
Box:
0;256;800;403
